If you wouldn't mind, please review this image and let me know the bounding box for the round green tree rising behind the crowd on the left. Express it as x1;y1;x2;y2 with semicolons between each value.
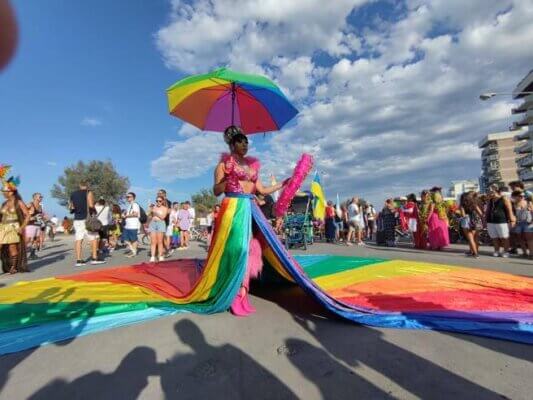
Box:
51;160;130;207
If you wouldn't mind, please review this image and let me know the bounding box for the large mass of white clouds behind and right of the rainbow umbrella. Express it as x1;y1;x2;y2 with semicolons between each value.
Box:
152;0;533;205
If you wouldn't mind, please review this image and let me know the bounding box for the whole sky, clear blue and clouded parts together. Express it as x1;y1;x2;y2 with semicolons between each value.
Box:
0;0;533;215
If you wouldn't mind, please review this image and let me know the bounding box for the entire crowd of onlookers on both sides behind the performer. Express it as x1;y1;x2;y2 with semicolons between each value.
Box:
0;170;533;273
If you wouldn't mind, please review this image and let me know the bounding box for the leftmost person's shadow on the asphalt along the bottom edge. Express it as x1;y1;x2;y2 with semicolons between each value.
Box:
28;346;159;400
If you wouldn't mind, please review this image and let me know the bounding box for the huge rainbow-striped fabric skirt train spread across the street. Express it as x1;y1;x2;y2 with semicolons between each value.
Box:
0;195;533;354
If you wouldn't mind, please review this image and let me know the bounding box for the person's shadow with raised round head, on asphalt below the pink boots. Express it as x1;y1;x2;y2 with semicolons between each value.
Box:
161;320;297;400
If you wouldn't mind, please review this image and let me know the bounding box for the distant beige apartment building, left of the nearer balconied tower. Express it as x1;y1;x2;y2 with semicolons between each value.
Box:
479;131;525;192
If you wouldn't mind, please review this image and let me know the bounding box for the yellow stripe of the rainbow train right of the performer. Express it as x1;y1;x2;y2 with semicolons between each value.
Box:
314;260;459;290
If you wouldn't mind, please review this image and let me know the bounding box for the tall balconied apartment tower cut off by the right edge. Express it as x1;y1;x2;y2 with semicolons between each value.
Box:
510;70;533;188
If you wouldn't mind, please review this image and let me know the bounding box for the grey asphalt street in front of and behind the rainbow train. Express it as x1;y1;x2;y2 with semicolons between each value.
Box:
0;238;533;399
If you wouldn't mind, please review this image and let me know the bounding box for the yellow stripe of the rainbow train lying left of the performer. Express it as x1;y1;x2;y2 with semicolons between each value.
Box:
0;278;170;304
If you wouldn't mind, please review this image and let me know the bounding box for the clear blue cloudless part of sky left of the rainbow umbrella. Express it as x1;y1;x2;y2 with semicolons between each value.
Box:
0;0;203;219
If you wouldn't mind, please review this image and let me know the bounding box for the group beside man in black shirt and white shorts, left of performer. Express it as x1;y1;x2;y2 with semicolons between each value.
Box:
70;182;195;266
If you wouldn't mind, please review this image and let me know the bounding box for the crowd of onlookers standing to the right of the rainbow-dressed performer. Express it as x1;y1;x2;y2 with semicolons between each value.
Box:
325;181;533;259
